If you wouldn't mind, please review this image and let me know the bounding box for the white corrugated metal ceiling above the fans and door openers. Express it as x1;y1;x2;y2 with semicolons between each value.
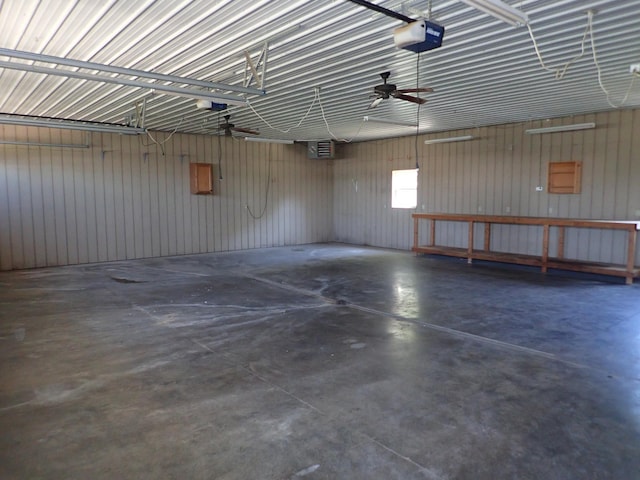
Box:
0;0;640;140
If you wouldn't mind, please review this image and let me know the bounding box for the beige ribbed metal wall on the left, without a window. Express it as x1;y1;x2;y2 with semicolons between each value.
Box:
0;126;333;270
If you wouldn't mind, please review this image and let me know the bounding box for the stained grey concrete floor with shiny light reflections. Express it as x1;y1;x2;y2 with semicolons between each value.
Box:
0;245;640;480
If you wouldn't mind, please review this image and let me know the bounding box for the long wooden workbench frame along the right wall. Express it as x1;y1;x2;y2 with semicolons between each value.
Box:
412;213;640;284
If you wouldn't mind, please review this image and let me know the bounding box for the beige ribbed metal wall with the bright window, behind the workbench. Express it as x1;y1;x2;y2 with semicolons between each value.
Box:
334;110;640;264
